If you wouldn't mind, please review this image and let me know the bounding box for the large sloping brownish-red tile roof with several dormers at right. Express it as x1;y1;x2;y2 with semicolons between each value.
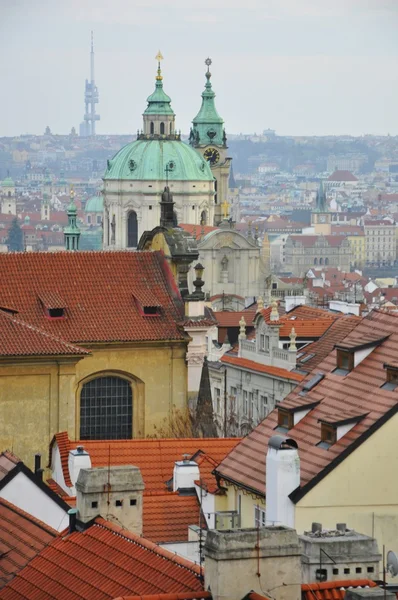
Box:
217;310;398;501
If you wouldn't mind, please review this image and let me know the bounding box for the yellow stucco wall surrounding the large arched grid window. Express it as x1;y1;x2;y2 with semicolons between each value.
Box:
0;343;187;466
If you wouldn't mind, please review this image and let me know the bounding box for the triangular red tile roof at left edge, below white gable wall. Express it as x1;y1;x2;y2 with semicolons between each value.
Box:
0;498;57;588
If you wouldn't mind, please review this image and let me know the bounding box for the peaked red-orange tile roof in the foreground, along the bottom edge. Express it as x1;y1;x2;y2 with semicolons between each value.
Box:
0;518;202;600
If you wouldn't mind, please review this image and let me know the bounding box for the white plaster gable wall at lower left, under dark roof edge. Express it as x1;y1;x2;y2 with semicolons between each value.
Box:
0;473;69;531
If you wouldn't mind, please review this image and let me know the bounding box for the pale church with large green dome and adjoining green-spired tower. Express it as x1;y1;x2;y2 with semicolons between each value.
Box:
103;53;230;249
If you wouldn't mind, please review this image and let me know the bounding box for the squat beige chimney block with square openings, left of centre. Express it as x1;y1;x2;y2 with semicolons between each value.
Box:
76;465;145;535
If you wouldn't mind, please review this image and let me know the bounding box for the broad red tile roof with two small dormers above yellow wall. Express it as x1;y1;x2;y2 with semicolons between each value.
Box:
0;251;186;343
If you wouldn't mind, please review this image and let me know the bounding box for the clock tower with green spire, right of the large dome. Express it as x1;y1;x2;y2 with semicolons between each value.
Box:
189;58;232;225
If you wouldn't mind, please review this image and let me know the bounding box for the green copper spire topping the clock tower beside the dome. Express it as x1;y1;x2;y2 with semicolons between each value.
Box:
189;58;227;146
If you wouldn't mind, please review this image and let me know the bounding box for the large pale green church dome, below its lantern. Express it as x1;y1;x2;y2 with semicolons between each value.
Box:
104;136;214;181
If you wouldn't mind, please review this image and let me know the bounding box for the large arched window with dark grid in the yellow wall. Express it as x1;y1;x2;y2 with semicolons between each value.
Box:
80;375;133;440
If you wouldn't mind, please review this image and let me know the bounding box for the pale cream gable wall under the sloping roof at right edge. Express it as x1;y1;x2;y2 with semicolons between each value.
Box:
296;415;398;551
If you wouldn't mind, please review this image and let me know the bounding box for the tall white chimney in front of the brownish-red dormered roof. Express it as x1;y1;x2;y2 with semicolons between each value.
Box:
265;435;300;528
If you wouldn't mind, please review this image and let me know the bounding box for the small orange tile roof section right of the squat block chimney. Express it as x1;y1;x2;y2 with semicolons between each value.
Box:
143;492;201;544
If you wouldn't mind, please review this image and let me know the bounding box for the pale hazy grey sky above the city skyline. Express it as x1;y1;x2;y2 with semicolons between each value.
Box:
0;0;398;136
